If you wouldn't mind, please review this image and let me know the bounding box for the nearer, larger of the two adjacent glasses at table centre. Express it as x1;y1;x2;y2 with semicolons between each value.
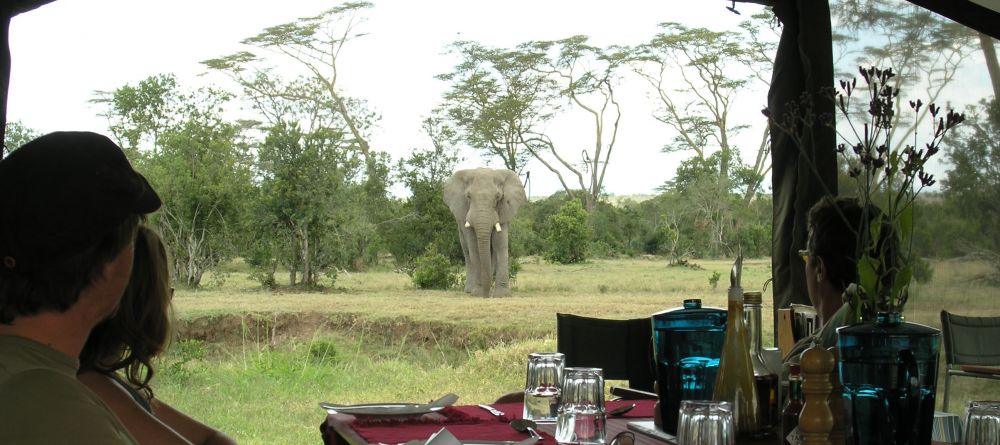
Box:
556;368;606;445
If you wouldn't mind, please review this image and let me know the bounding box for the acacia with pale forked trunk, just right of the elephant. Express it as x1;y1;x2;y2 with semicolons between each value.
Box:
518;35;626;213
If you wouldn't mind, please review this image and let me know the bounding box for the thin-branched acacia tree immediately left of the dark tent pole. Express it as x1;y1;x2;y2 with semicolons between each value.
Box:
629;15;776;202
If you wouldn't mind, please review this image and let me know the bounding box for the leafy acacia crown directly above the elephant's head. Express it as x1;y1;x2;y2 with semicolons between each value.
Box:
437;41;556;173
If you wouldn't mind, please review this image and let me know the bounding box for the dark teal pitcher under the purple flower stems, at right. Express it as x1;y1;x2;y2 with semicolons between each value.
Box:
837;312;941;445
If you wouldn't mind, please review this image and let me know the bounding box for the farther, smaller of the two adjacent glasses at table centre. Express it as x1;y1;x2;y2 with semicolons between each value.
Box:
523;352;566;421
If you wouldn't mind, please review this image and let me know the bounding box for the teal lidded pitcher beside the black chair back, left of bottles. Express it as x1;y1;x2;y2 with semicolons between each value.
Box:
652;299;726;434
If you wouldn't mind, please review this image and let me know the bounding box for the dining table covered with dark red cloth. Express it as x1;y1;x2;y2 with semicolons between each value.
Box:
320;400;778;445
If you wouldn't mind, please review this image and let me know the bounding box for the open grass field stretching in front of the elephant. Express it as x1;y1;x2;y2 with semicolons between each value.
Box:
154;259;1000;444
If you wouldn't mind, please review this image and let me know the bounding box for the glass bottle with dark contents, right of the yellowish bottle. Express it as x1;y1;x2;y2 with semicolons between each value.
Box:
743;292;779;436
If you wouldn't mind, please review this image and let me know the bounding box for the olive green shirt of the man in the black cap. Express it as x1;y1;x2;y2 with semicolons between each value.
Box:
0;335;137;445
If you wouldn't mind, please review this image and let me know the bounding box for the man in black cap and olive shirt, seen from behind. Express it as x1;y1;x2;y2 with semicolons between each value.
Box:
0;132;160;444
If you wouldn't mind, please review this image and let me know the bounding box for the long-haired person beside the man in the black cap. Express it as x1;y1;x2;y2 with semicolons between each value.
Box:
77;225;236;445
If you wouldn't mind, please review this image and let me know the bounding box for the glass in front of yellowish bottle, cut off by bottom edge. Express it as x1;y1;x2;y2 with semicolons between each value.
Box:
677;400;736;445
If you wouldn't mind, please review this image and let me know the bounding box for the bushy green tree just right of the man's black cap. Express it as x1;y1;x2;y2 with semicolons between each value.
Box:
95;75;251;287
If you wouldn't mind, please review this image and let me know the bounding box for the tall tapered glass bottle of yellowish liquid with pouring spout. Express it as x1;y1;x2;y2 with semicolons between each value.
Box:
712;282;760;439
